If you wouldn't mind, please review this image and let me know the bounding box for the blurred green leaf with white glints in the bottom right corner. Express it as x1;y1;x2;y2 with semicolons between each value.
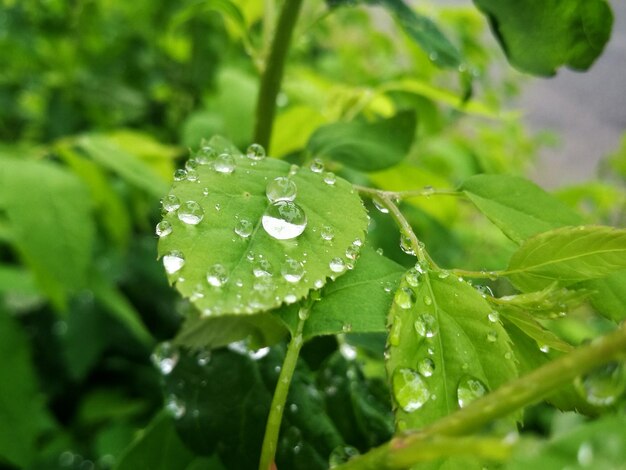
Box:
505;414;626;470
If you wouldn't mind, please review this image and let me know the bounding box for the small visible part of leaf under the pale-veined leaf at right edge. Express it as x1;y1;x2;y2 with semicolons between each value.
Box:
582;271;626;322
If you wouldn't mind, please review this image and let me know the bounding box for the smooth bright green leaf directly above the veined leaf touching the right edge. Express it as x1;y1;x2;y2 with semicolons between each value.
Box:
461;175;581;243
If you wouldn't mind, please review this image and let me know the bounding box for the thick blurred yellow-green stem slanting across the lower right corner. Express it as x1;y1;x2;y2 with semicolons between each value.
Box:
337;322;626;470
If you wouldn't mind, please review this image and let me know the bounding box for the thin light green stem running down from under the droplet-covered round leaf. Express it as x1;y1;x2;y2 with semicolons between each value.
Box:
259;304;311;470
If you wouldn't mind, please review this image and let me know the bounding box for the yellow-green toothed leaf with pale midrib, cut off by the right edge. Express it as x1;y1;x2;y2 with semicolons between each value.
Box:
507;226;626;292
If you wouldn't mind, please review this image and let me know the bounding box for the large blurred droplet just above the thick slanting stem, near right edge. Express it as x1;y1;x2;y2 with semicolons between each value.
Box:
574;362;626;406
